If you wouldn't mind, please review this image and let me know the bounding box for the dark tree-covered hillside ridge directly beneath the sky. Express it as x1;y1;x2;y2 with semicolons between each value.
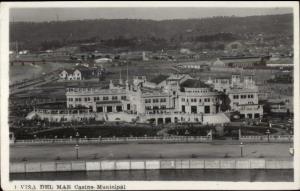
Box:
10;14;293;49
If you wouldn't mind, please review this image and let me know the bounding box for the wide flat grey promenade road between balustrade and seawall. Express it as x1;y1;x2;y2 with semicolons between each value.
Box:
10;143;291;162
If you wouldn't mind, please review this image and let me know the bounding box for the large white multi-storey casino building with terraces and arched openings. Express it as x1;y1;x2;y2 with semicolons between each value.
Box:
27;74;262;124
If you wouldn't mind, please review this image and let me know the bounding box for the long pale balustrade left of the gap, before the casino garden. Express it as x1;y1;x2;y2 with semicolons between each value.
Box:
13;136;212;144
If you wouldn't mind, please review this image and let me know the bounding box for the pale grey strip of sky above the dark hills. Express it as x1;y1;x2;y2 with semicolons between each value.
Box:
10;7;292;22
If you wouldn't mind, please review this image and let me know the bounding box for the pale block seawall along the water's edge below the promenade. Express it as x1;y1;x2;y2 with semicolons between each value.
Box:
9;158;294;173
